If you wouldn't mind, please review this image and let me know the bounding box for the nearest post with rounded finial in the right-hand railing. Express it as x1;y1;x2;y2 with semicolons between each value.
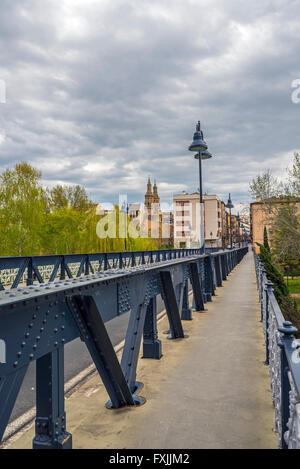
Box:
278;321;298;449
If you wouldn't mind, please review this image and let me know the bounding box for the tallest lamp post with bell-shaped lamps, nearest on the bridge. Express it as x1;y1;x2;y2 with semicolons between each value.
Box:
189;121;212;254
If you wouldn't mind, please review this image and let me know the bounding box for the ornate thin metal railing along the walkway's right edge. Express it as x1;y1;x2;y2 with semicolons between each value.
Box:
253;250;300;449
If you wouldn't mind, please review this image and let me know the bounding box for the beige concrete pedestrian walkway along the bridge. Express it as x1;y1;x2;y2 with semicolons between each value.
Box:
10;253;277;449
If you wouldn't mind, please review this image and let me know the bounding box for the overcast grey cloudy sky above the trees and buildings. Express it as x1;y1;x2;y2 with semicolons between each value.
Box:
0;0;300;208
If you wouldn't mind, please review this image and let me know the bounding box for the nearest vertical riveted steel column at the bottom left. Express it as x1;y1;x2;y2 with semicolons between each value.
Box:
33;347;72;449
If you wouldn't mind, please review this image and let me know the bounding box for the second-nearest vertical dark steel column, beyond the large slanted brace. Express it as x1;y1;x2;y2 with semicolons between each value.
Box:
143;296;162;360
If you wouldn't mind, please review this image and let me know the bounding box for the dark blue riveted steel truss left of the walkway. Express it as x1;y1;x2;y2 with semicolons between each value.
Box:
0;247;248;449
